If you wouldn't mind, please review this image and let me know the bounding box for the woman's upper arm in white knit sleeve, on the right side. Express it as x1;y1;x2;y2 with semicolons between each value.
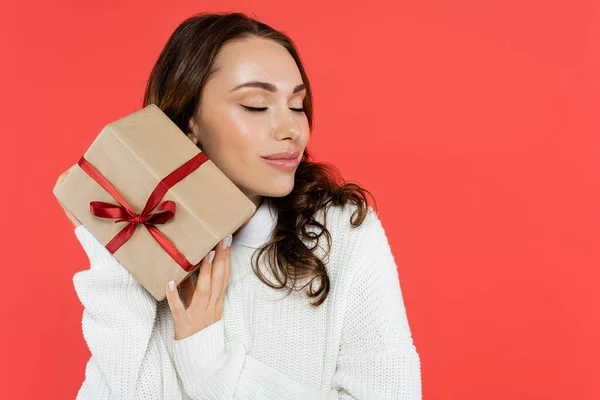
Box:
333;211;421;400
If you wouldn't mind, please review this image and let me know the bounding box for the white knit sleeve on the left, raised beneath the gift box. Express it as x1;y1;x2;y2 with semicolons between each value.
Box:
73;225;182;400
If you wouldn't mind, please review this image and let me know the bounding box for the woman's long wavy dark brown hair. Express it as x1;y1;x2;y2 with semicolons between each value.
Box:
143;13;375;306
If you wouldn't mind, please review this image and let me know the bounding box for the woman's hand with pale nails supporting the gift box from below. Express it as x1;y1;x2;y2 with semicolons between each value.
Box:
166;235;232;340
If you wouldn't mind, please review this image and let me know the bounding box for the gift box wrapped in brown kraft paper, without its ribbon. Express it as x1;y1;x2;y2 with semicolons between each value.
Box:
54;104;256;300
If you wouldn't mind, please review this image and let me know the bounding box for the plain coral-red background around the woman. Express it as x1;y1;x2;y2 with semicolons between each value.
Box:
0;0;600;400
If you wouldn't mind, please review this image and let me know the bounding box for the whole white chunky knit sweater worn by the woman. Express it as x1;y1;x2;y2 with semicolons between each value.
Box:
73;201;421;400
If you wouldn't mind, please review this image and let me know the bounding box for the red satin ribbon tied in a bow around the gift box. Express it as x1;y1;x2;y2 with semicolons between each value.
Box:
77;152;208;272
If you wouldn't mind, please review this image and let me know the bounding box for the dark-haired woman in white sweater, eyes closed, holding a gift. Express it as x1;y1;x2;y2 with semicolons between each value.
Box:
59;13;421;400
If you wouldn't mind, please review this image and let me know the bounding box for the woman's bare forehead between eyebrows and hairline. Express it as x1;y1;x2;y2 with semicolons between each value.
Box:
213;37;303;91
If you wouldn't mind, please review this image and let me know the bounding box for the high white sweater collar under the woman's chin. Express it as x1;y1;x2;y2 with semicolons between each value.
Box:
233;198;277;249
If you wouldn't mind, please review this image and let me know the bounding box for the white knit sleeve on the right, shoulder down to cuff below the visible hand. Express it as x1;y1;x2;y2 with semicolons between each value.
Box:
169;208;421;400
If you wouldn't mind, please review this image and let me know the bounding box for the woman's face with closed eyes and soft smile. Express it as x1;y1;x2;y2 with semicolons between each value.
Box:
189;38;310;205
